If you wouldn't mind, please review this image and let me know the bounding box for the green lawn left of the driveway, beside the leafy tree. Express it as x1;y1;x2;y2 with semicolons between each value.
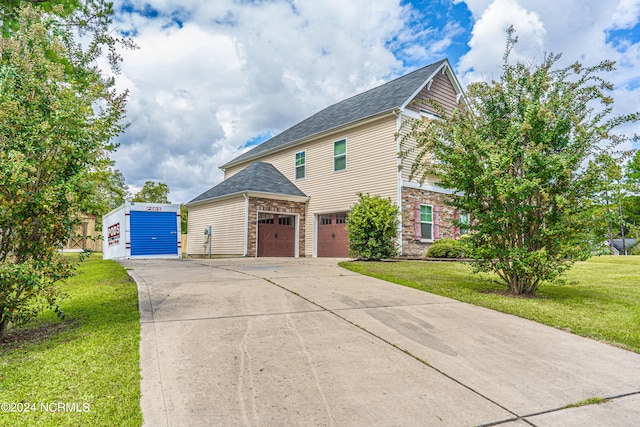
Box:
0;255;142;426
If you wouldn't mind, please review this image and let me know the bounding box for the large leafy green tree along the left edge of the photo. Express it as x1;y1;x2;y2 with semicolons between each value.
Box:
0;6;126;337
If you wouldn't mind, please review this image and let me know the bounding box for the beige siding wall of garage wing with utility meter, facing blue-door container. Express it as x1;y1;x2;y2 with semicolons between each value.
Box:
187;196;246;255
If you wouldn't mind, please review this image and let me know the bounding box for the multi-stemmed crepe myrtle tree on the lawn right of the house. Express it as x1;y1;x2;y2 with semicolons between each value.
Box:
401;28;640;294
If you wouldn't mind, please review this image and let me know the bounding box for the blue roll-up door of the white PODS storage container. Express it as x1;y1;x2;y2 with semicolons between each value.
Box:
129;211;178;256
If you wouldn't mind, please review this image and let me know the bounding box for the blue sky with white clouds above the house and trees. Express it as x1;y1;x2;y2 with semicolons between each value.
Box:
113;0;640;203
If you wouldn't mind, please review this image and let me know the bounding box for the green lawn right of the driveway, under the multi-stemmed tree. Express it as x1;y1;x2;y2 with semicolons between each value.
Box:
340;256;640;353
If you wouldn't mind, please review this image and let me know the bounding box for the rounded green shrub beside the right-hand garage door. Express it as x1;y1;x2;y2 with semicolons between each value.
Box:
347;193;399;260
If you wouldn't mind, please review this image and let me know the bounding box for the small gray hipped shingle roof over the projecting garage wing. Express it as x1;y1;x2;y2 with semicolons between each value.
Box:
187;162;306;204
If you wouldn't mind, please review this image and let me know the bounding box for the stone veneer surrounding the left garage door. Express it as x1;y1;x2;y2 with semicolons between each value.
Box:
247;197;306;257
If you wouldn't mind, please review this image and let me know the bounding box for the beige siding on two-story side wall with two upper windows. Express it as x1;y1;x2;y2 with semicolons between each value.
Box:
225;114;398;255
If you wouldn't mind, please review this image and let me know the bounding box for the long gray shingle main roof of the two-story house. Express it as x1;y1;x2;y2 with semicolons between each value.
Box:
222;59;447;169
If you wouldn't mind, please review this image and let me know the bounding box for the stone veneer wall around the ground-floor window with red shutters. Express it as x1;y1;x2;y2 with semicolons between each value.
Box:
402;187;455;257
